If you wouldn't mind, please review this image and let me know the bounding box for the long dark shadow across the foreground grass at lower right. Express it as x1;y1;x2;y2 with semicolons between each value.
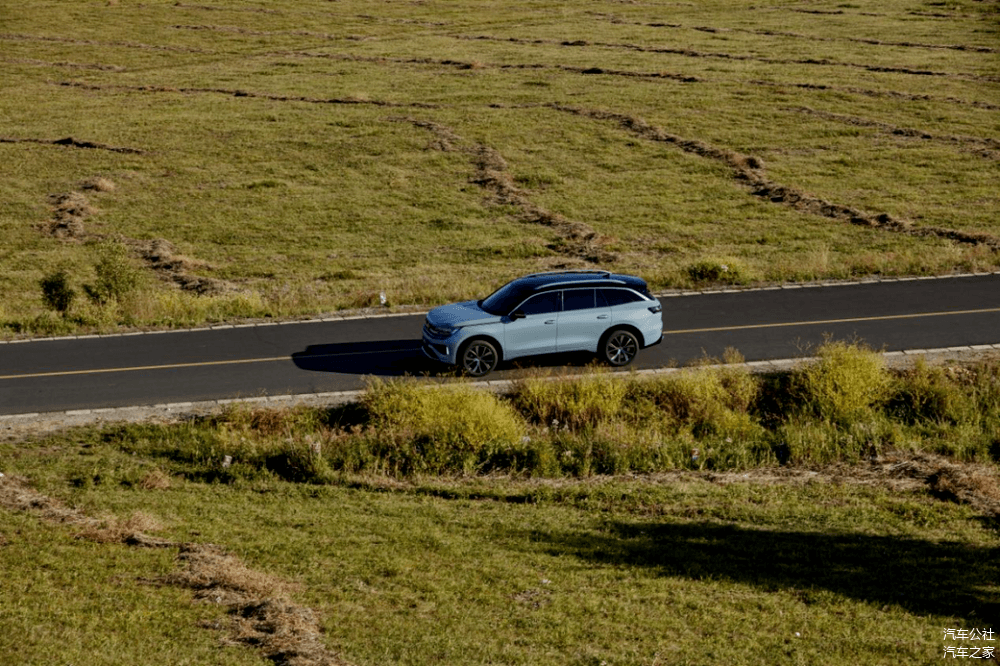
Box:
529;522;1000;619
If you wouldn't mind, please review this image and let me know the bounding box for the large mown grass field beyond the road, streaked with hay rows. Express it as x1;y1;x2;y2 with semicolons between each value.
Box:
0;0;1000;336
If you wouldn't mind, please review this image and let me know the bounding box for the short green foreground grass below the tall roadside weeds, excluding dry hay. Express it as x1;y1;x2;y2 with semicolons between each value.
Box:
0;431;1000;664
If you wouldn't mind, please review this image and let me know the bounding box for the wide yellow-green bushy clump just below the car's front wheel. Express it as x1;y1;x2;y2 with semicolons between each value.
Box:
362;380;527;474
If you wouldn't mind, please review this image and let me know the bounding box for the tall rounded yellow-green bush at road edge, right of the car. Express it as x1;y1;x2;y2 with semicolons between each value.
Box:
792;342;889;425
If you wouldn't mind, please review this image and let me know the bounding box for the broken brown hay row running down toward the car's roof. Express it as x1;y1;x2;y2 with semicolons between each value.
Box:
395;118;615;263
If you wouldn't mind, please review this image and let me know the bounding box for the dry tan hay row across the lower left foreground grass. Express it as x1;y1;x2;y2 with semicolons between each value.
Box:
0;476;348;666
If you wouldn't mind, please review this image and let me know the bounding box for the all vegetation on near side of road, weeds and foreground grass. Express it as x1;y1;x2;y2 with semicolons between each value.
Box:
0;344;1000;666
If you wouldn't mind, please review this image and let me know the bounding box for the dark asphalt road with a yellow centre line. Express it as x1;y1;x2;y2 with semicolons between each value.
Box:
0;275;1000;414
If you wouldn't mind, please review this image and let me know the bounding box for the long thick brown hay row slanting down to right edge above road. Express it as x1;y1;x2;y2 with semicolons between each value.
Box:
545;103;1000;251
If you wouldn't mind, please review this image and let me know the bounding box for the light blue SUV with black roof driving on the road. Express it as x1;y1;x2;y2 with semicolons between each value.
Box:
423;271;663;377
